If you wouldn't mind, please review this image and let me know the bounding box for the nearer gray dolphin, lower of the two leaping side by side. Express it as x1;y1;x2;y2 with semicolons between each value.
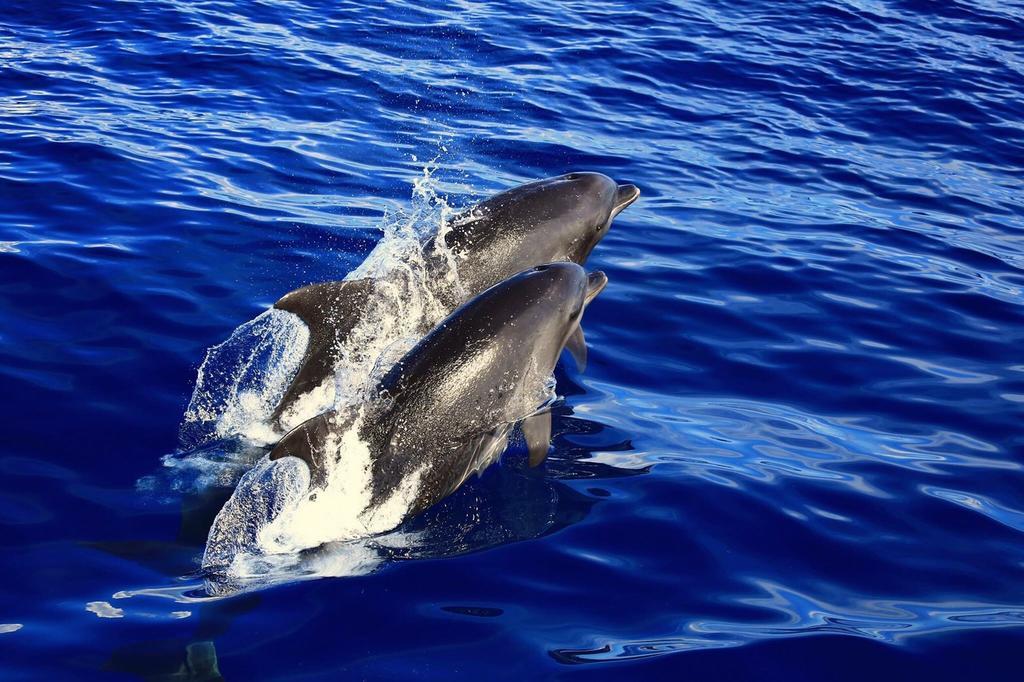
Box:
270;262;607;518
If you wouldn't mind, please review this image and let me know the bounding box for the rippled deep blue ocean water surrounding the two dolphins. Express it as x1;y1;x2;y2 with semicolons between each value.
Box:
0;0;1024;680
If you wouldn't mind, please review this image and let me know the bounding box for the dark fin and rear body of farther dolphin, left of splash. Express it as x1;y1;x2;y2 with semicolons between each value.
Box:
271;280;373;424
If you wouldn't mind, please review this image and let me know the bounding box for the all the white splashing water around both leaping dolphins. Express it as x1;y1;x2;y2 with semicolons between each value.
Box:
189;165;507;580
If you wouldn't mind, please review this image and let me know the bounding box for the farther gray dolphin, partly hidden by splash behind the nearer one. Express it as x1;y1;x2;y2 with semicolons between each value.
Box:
270;173;640;427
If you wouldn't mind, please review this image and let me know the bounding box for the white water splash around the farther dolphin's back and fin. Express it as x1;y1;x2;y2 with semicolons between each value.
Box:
181;160;467;447
